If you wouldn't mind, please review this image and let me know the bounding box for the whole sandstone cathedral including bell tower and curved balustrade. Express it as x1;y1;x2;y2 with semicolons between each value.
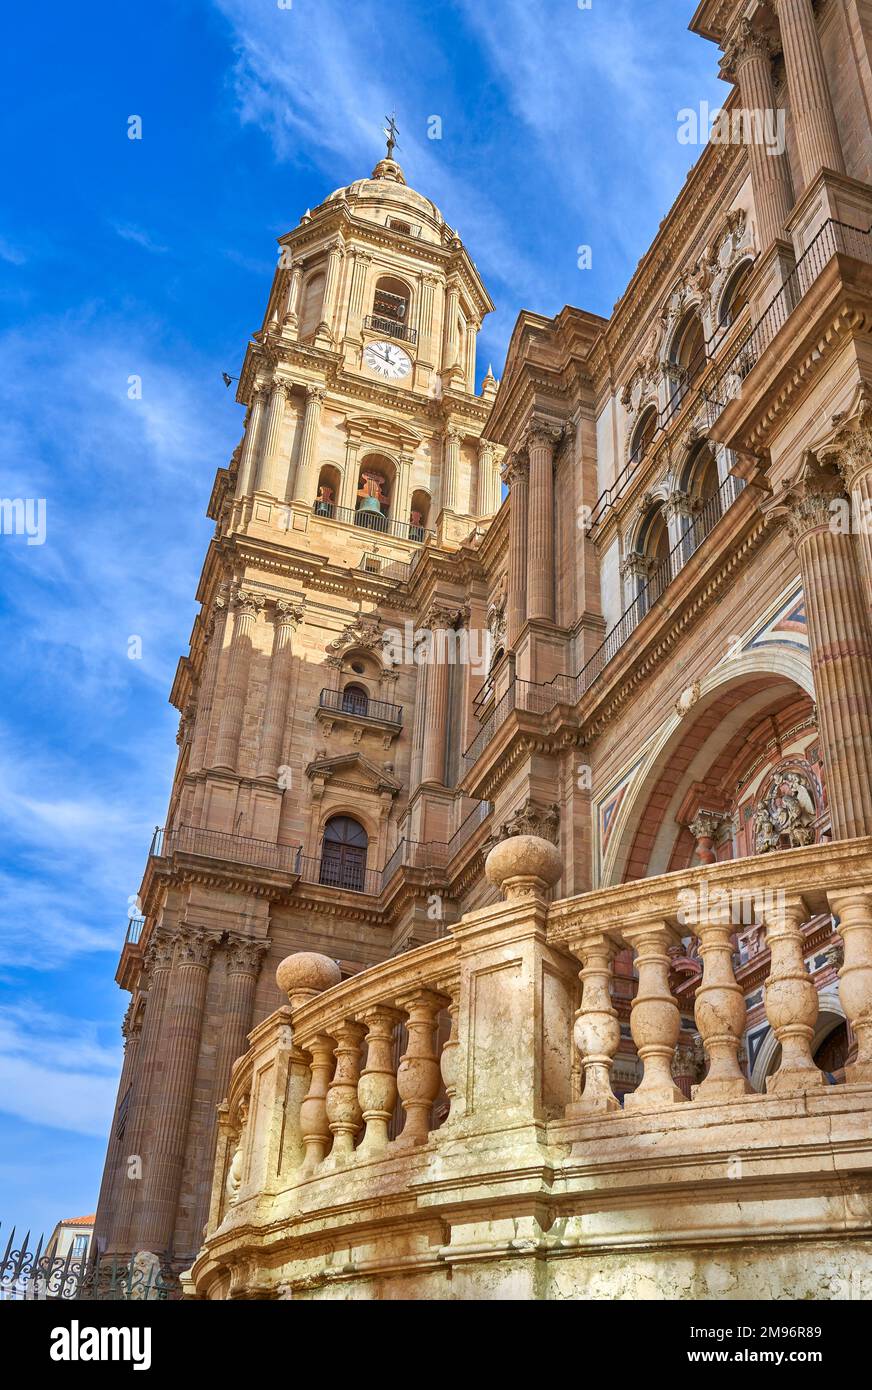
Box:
96;0;872;1297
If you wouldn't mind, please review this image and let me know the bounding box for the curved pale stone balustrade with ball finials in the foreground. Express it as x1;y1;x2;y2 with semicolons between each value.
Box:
184;835;872;1298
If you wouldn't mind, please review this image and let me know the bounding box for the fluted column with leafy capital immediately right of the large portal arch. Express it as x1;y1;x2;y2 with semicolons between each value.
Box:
775;456;872;838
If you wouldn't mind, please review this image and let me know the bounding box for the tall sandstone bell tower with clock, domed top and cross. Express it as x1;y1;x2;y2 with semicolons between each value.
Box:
96;138;501;1268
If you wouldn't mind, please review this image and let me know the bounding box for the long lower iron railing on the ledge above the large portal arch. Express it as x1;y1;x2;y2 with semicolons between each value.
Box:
463;477;744;771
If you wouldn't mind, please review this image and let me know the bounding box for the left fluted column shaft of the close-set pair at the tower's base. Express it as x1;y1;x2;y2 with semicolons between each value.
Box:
108;929;172;1254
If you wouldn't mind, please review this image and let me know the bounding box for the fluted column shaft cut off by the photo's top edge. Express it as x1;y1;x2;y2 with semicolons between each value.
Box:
775;0;844;186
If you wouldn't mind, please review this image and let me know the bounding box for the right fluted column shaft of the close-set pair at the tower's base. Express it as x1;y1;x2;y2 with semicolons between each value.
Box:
136;930;216;1254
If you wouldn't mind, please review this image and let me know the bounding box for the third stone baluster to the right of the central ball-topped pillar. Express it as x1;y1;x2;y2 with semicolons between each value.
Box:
694;909;751;1101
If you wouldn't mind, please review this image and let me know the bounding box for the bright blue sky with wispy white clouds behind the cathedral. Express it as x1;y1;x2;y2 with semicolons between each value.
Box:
0;0;726;1237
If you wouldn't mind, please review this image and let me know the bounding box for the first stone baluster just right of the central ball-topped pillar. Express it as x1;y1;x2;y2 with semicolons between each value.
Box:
566;935;620;1119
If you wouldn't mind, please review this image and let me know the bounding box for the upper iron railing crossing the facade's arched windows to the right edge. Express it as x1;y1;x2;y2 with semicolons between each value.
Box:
590;218;872;527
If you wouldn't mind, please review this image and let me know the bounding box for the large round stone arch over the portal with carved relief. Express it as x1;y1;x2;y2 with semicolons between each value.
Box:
599;648;815;887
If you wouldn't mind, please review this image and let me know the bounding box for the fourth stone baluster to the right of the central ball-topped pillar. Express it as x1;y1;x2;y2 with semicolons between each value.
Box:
764;898;823;1095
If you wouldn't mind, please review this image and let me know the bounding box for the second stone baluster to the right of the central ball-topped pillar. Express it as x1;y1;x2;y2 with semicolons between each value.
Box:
623;923;687;1111
